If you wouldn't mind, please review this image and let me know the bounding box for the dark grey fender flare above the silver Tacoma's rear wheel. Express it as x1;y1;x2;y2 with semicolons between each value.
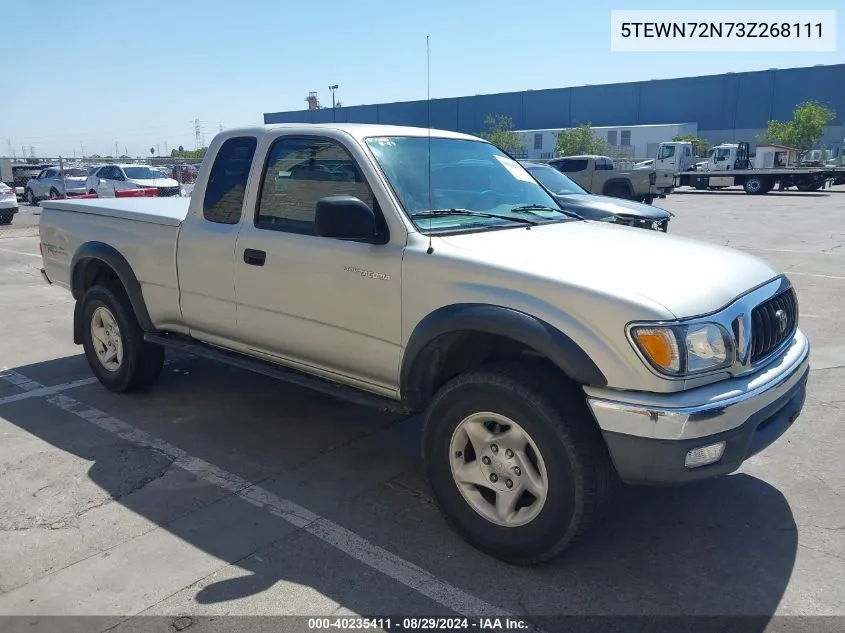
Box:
70;242;155;345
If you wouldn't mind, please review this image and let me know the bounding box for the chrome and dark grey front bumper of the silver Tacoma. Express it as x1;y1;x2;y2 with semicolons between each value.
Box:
587;330;810;485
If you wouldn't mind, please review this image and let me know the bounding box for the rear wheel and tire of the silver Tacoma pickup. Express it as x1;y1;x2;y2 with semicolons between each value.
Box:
82;285;164;393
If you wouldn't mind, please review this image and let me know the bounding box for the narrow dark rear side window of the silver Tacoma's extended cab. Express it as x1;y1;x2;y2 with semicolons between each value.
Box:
202;136;258;224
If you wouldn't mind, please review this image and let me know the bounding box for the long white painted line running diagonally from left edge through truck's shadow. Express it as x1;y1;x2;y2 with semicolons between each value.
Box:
0;370;516;630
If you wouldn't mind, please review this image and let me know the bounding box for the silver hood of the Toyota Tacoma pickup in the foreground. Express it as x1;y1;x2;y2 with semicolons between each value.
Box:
441;220;780;318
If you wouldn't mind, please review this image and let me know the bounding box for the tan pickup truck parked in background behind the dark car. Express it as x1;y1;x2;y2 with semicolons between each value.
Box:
547;155;675;204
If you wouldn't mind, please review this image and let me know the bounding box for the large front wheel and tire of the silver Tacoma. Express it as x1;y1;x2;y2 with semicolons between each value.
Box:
423;365;614;565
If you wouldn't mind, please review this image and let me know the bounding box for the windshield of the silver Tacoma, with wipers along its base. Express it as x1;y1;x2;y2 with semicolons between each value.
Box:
366;136;571;232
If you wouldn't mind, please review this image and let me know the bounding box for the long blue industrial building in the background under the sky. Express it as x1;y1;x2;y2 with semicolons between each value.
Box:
264;64;845;153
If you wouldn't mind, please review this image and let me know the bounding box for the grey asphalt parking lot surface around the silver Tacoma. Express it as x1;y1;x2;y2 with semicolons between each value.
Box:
0;187;845;631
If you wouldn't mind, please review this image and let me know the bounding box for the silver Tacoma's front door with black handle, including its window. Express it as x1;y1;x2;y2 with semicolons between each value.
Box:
229;135;405;392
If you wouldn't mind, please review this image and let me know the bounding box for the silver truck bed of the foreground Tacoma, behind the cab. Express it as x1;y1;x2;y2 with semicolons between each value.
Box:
40;198;190;324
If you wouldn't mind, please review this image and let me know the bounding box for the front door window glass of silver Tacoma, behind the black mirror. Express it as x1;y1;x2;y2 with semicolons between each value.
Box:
255;138;375;235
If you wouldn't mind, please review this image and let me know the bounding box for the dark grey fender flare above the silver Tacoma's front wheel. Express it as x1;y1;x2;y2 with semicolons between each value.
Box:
399;303;607;409
